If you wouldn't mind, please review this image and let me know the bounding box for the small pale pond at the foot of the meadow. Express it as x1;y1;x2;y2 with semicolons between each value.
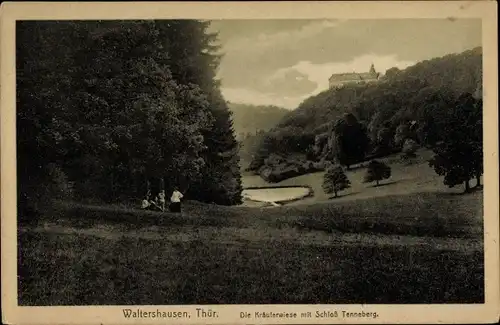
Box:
242;186;312;203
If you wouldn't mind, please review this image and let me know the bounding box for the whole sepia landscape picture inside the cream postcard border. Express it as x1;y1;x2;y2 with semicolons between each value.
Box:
2;1;498;323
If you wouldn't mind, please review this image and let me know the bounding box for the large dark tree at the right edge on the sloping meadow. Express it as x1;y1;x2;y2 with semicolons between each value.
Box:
429;93;483;192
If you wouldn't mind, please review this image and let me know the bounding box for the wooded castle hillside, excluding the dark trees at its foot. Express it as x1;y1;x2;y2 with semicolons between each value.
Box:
250;48;482;180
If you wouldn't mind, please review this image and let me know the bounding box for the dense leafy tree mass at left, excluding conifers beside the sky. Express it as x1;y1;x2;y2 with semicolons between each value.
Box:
17;21;216;209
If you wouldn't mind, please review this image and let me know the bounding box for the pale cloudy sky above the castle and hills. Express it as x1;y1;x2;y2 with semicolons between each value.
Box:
210;19;481;109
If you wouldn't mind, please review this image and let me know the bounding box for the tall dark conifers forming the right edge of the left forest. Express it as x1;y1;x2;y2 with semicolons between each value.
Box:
158;20;242;205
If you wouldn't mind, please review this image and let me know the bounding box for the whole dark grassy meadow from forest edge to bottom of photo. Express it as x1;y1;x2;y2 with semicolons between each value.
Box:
19;151;484;305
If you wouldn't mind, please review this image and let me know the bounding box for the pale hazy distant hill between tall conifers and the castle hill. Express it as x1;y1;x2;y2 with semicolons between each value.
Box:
229;103;290;139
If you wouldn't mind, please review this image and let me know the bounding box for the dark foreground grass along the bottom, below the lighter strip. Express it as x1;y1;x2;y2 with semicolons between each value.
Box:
19;229;483;305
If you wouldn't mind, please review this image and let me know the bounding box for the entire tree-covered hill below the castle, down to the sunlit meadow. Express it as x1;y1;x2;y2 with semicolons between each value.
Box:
250;48;482;187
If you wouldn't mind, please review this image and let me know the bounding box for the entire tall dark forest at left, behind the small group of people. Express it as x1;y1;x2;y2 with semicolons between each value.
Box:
16;20;242;213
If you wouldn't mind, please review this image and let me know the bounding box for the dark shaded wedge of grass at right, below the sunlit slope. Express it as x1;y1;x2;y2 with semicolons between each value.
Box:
284;192;483;238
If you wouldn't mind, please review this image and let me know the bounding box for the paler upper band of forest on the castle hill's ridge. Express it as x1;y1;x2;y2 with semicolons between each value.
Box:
278;47;482;133
